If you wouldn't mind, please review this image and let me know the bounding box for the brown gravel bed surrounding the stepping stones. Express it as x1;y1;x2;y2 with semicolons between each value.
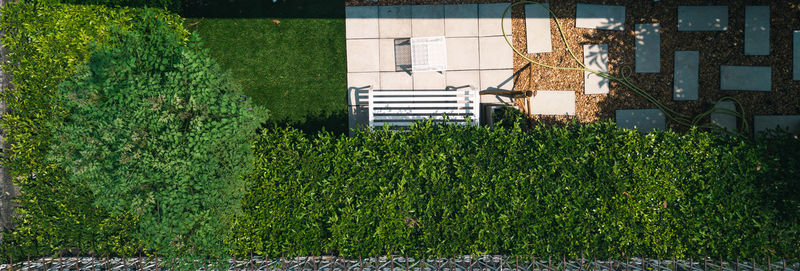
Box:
345;0;800;128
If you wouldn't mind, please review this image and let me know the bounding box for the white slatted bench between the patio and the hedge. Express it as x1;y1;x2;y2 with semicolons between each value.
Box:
368;86;481;127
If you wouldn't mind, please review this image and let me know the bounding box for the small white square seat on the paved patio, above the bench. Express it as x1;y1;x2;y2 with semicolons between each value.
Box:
411;36;447;72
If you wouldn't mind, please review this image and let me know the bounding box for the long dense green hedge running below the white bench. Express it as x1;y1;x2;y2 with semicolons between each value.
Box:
234;120;800;259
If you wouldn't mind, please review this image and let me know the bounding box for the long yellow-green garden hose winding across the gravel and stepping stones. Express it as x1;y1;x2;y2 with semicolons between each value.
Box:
500;1;749;133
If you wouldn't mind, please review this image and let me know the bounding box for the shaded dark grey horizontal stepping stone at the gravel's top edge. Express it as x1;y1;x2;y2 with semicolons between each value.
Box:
678;6;728;31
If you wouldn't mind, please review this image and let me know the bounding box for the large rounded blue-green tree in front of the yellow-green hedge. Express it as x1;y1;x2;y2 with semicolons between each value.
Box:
48;10;266;262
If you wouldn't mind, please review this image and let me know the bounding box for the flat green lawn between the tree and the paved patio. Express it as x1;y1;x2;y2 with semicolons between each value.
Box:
186;1;347;132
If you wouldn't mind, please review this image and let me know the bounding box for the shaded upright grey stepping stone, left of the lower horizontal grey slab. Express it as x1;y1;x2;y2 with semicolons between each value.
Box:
672;51;700;101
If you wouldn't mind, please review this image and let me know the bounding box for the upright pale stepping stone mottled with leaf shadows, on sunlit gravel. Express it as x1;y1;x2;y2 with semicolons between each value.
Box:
583;44;609;95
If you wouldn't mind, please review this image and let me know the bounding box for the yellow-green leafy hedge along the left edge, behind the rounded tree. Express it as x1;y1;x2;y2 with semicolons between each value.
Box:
0;1;188;257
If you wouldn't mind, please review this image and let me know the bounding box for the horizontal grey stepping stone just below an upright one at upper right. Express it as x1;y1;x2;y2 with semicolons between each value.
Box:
719;66;772;91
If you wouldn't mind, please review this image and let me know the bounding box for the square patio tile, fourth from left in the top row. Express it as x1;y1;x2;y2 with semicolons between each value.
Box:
444;4;478;37
